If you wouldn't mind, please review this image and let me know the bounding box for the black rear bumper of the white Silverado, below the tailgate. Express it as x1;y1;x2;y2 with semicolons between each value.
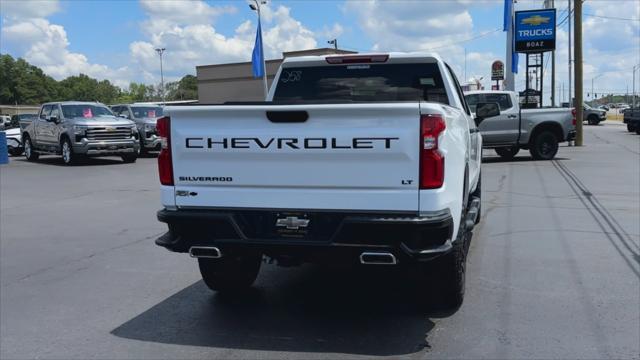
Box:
156;210;453;263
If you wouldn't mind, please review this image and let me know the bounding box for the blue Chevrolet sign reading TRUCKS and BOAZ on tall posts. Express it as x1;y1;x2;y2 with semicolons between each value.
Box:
514;9;556;52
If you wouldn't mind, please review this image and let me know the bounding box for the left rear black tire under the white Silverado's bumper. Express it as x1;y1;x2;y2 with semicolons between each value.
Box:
198;253;262;292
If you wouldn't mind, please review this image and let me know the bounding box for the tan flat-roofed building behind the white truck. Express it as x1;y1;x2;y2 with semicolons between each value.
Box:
196;48;357;104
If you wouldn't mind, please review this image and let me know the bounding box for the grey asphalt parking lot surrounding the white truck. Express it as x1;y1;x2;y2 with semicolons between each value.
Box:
0;122;640;359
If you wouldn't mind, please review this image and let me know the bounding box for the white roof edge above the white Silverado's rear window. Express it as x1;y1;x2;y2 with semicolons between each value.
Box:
282;52;442;66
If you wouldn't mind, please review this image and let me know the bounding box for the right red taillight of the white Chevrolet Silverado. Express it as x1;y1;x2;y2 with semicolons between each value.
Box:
420;114;447;189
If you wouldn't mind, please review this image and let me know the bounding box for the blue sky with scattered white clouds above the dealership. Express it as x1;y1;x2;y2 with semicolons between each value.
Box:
0;0;640;101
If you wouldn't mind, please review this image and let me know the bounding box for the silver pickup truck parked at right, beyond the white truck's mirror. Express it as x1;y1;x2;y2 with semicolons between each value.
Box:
464;90;576;160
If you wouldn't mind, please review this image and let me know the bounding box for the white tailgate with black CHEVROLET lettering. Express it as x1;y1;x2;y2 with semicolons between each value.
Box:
167;102;420;212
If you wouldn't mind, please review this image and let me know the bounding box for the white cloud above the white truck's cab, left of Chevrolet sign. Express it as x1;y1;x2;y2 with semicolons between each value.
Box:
343;0;504;83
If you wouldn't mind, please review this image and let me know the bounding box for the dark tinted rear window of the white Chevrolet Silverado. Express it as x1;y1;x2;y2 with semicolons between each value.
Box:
273;64;449;104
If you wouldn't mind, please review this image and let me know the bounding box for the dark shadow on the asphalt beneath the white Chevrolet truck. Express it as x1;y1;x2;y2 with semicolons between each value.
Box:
111;266;440;357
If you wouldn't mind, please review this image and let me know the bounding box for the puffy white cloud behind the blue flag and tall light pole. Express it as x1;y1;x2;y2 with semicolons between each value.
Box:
129;1;317;78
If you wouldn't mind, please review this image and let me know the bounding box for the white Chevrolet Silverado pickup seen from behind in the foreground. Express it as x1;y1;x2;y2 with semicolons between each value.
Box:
156;53;499;306
